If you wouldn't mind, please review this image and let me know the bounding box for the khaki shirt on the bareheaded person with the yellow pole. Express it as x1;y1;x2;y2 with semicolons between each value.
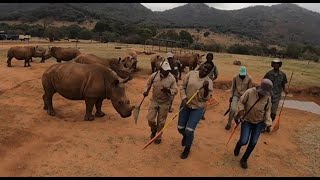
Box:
180;71;213;109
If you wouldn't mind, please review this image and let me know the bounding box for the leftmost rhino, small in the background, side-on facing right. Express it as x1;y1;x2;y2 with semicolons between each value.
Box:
7;46;44;67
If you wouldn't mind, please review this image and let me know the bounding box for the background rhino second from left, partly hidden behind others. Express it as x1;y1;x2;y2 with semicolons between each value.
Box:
49;46;81;63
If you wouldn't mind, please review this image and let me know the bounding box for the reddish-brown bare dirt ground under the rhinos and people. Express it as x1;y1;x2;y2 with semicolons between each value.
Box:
0;41;320;176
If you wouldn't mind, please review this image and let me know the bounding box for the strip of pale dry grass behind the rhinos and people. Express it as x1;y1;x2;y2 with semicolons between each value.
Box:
0;41;320;88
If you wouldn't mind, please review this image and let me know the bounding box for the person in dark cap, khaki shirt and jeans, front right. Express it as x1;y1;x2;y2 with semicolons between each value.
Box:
234;79;273;169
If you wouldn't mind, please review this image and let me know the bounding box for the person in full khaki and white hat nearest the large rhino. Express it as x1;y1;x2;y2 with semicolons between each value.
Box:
143;61;178;144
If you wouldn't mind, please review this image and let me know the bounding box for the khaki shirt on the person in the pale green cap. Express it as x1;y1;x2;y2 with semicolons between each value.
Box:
231;74;252;97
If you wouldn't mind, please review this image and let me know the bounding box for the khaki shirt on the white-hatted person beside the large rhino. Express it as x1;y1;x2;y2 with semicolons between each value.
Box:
144;72;178;103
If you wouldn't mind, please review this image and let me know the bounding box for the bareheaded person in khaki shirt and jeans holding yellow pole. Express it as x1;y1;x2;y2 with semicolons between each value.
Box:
178;62;214;159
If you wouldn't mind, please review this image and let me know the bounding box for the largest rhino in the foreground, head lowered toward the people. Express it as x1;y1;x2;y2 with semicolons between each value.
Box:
42;63;134;121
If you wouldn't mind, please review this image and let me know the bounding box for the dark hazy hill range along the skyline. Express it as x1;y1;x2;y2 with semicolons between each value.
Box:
0;3;320;46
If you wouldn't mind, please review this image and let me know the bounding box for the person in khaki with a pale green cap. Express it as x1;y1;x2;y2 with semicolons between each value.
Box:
225;66;252;130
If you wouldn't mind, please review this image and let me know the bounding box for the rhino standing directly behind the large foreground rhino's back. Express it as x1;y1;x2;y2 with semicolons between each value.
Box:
74;54;132;78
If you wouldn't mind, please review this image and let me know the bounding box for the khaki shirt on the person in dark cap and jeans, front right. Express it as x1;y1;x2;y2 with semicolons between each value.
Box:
238;87;272;126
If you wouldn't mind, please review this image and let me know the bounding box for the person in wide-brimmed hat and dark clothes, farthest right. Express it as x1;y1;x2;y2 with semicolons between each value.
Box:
263;58;288;132
